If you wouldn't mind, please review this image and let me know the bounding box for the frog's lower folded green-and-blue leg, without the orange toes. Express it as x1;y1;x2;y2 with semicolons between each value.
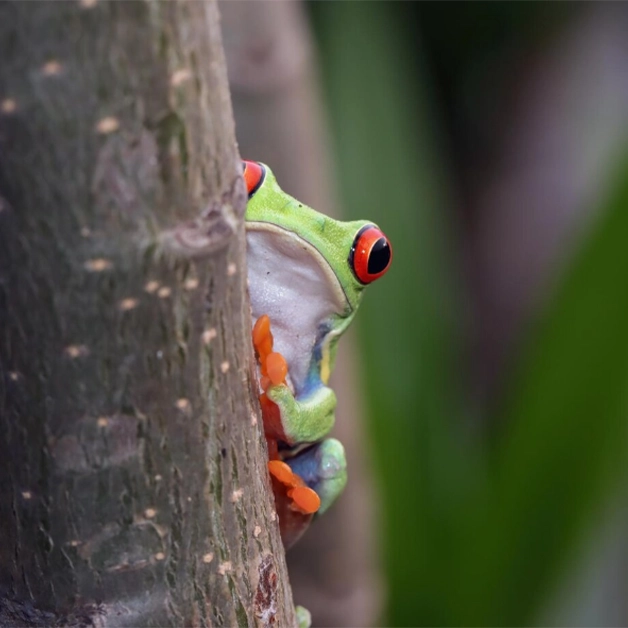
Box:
285;438;347;514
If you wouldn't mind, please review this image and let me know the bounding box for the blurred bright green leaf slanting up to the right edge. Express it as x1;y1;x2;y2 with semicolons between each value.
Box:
457;156;628;625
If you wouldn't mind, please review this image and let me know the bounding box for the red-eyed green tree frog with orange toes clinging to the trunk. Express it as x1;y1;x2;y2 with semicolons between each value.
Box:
242;161;392;547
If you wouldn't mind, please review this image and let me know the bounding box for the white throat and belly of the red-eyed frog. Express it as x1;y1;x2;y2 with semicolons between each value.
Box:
246;222;347;393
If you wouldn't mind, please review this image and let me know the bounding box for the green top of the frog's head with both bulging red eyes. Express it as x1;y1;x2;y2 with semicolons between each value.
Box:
243;161;392;316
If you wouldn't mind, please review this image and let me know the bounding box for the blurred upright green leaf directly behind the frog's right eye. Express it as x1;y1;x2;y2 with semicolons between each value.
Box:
312;2;473;625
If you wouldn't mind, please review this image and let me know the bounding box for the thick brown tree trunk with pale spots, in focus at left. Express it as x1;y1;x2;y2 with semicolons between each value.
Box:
0;0;296;626
